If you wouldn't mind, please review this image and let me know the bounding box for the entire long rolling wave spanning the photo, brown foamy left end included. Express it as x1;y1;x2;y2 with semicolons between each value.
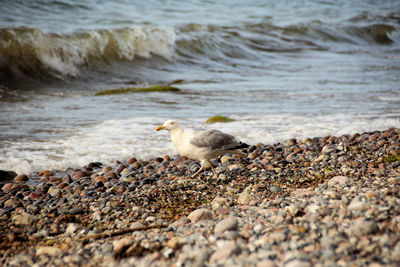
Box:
0;17;400;84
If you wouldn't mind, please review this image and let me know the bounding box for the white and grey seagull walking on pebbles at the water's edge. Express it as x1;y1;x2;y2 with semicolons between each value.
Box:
156;120;249;178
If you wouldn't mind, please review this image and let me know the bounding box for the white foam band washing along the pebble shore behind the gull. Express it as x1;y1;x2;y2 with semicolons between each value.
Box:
0;114;400;173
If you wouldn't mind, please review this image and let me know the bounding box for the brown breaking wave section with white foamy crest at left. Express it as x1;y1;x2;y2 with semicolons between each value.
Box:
0;26;175;82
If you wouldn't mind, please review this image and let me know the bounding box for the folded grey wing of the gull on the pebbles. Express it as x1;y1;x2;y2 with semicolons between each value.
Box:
190;130;242;150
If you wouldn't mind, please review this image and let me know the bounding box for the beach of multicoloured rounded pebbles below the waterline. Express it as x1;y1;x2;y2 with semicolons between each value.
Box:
0;128;400;267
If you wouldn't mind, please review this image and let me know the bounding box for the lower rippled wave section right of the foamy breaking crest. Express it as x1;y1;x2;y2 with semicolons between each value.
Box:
176;21;400;61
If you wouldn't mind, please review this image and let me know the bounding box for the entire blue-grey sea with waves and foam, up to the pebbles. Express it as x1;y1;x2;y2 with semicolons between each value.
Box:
0;0;400;173
